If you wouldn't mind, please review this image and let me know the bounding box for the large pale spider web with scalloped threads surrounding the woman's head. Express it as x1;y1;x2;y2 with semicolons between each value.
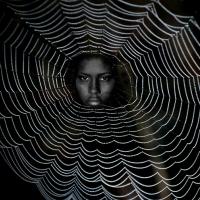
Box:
0;0;200;200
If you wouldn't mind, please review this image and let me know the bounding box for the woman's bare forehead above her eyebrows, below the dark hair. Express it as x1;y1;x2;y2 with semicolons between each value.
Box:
78;58;111;74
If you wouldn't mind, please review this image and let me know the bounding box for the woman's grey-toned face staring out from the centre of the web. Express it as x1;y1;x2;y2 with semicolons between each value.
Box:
76;58;115;106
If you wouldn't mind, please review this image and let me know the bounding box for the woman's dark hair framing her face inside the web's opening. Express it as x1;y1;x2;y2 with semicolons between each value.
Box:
66;53;131;107
